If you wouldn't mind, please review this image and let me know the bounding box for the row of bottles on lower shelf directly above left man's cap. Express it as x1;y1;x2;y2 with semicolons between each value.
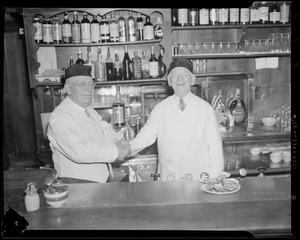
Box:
70;45;166;82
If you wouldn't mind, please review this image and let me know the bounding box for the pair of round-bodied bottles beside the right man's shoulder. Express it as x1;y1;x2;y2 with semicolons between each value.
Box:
211;88;247;127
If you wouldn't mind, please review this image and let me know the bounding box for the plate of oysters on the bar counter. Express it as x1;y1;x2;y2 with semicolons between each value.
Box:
200;173;241;195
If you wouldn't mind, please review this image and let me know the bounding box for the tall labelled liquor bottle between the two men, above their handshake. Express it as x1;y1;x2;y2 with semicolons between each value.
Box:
112;85;125;129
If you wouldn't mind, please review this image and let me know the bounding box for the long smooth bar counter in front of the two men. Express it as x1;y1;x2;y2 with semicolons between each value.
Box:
4;175;291;236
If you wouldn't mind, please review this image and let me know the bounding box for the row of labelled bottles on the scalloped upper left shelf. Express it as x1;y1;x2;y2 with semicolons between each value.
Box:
33;11;163;44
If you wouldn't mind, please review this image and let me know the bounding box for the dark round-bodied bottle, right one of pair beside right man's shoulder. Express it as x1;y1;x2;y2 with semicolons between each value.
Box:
229;88;246;126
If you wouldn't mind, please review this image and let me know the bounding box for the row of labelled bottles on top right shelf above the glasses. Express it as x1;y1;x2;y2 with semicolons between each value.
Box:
172;1;290;26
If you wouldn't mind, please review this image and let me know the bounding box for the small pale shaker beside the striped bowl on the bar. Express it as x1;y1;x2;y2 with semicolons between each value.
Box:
25;182;40;212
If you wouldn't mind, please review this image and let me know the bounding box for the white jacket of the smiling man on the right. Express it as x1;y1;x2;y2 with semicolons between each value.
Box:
130;93;224;180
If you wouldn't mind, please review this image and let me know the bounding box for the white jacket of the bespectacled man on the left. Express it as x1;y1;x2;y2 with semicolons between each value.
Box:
47;97;122;182
